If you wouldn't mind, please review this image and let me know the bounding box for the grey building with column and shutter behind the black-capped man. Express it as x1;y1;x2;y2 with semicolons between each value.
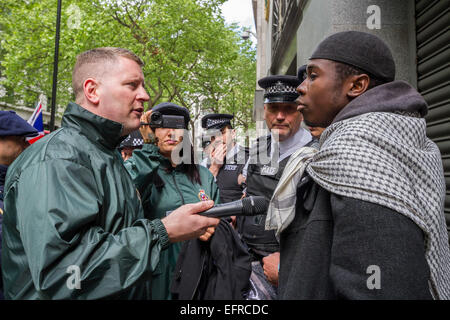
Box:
252;0;450;235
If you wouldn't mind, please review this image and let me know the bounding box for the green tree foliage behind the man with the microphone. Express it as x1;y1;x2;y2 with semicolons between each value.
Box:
0;0;256;135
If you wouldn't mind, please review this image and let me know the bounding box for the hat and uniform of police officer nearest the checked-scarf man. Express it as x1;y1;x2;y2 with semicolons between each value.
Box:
237;72;312;260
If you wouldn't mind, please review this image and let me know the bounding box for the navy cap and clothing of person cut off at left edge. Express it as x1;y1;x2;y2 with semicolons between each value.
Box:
0;111;39;300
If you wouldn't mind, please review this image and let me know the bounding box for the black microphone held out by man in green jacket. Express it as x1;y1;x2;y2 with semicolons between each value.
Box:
198;196;269;218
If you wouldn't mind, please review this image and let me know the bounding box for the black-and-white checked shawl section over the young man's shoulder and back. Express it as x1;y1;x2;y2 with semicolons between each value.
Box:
306;112;450;299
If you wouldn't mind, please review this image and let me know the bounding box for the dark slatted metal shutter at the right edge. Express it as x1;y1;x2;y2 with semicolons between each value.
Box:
416;0;450;238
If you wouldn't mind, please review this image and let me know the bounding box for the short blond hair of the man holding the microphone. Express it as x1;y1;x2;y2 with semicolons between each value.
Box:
72;47;144;101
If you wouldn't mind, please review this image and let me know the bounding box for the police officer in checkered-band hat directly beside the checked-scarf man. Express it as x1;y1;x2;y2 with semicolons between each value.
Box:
237;75;312;299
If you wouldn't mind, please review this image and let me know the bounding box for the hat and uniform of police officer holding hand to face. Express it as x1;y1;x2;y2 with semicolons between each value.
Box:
202;113;249;203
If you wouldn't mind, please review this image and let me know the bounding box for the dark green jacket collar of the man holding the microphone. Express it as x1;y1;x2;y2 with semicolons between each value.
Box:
61;102;126;149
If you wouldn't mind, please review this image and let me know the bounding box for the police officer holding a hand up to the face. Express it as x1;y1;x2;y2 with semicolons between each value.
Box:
202;113;249;203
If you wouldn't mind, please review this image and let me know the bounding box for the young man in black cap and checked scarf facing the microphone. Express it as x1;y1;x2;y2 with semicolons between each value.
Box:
274;31;450;299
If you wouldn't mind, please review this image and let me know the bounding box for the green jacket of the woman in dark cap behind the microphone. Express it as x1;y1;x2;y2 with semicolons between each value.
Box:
125;144;219;300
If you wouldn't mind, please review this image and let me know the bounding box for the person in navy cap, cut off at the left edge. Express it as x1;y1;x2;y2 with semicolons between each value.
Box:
0;111;39;300
